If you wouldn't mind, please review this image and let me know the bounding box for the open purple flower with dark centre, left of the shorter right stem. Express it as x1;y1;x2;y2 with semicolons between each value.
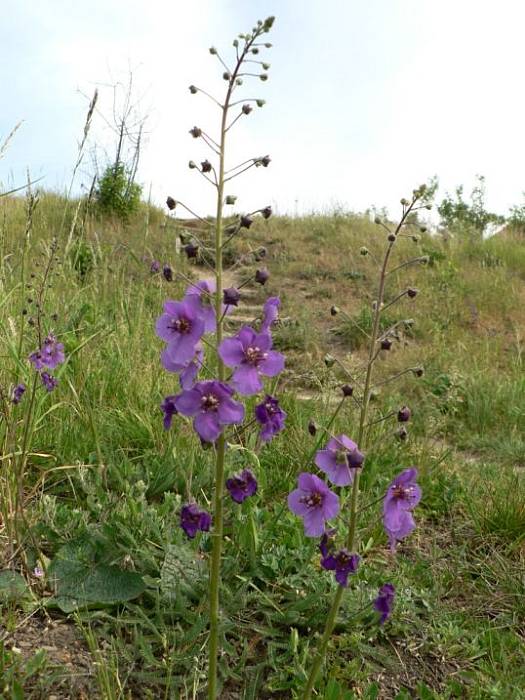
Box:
288;472;339;537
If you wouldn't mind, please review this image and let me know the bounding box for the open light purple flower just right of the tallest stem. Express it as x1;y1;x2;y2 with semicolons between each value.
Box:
219;326;284;396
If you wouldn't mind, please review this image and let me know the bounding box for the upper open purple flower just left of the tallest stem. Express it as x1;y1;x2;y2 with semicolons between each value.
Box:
155;301;204;365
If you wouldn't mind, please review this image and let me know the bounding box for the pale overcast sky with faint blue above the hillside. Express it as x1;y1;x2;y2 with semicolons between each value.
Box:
0;0;525;219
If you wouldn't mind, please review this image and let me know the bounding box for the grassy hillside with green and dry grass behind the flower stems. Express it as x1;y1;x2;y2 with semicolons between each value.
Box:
0;194;525;700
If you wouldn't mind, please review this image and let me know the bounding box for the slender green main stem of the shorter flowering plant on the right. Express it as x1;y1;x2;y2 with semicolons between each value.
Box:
303;186;425;700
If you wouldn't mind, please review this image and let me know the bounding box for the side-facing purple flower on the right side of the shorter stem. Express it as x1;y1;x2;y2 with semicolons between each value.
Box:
383;467;421;551
